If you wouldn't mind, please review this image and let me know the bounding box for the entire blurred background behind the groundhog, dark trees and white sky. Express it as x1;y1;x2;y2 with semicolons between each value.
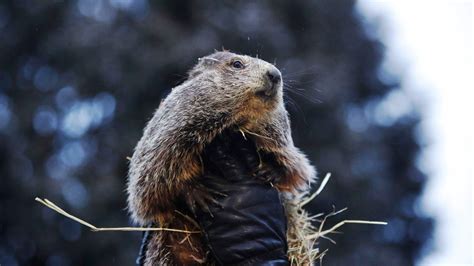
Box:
0;0;474;266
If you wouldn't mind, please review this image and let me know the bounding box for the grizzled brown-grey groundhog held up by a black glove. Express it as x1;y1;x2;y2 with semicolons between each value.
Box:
127;51;316;265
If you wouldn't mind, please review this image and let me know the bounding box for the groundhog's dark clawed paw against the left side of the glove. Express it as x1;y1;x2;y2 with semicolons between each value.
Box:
184;184;226;216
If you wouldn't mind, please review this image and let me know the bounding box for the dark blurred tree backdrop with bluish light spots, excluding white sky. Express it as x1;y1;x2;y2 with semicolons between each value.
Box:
0;0;432;266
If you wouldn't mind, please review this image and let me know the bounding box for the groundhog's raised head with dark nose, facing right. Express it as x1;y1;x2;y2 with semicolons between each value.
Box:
184;51;283;123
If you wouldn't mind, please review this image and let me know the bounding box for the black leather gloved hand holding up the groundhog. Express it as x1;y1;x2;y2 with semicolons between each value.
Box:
196;132;288;265
